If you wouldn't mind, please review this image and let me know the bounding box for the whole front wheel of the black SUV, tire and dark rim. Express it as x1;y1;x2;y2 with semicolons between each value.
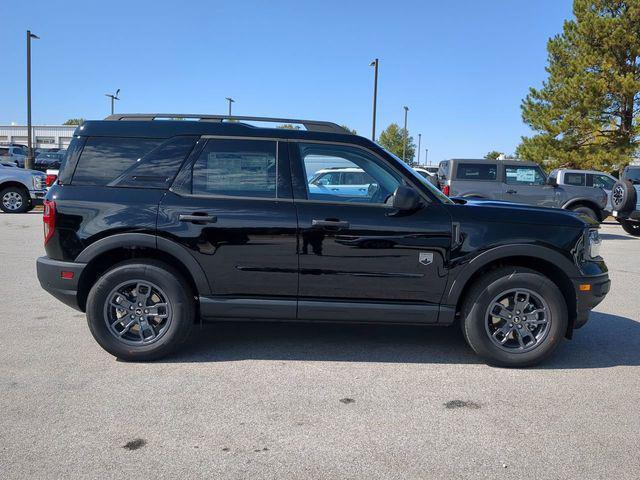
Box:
461;267;568;367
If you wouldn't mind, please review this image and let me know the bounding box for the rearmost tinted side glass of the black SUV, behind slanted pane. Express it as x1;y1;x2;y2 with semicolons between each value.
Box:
72;137;162;186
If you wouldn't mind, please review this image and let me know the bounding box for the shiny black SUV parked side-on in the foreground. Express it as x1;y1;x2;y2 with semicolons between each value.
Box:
37;114;610;366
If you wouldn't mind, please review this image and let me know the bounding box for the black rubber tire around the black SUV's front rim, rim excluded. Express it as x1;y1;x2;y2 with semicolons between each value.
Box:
461;267;568;367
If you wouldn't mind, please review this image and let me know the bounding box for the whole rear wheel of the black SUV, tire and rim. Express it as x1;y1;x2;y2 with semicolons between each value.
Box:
87;260;195;360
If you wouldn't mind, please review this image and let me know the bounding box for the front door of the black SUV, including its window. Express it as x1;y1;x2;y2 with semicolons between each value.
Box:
290;142;451;323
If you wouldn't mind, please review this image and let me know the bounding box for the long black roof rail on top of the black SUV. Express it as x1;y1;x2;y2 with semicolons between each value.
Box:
105;113;353;135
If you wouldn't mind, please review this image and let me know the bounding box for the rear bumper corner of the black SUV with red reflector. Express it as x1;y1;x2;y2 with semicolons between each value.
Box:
36;257;86;311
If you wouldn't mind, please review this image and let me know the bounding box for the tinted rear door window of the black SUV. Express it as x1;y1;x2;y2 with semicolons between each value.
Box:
192;140;277;198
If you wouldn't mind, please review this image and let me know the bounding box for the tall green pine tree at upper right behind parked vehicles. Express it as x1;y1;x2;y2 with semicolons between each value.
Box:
516;0;640;170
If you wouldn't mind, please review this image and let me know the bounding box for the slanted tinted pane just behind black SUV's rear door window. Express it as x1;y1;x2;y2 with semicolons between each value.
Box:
109;137;198;188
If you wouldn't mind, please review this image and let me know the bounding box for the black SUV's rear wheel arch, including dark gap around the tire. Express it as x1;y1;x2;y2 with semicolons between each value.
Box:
75;233;211;311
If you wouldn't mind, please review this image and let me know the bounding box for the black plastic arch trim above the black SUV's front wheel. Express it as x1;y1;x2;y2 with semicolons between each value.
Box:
442;244;581;305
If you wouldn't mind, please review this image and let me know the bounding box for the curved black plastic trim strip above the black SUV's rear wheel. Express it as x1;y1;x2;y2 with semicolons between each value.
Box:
75;233;211;295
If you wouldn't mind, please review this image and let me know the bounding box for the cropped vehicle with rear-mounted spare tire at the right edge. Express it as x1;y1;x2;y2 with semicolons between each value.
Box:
611;165;640;237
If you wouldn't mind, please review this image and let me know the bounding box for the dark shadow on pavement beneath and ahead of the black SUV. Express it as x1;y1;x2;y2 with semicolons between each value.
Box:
152;312;640;369
